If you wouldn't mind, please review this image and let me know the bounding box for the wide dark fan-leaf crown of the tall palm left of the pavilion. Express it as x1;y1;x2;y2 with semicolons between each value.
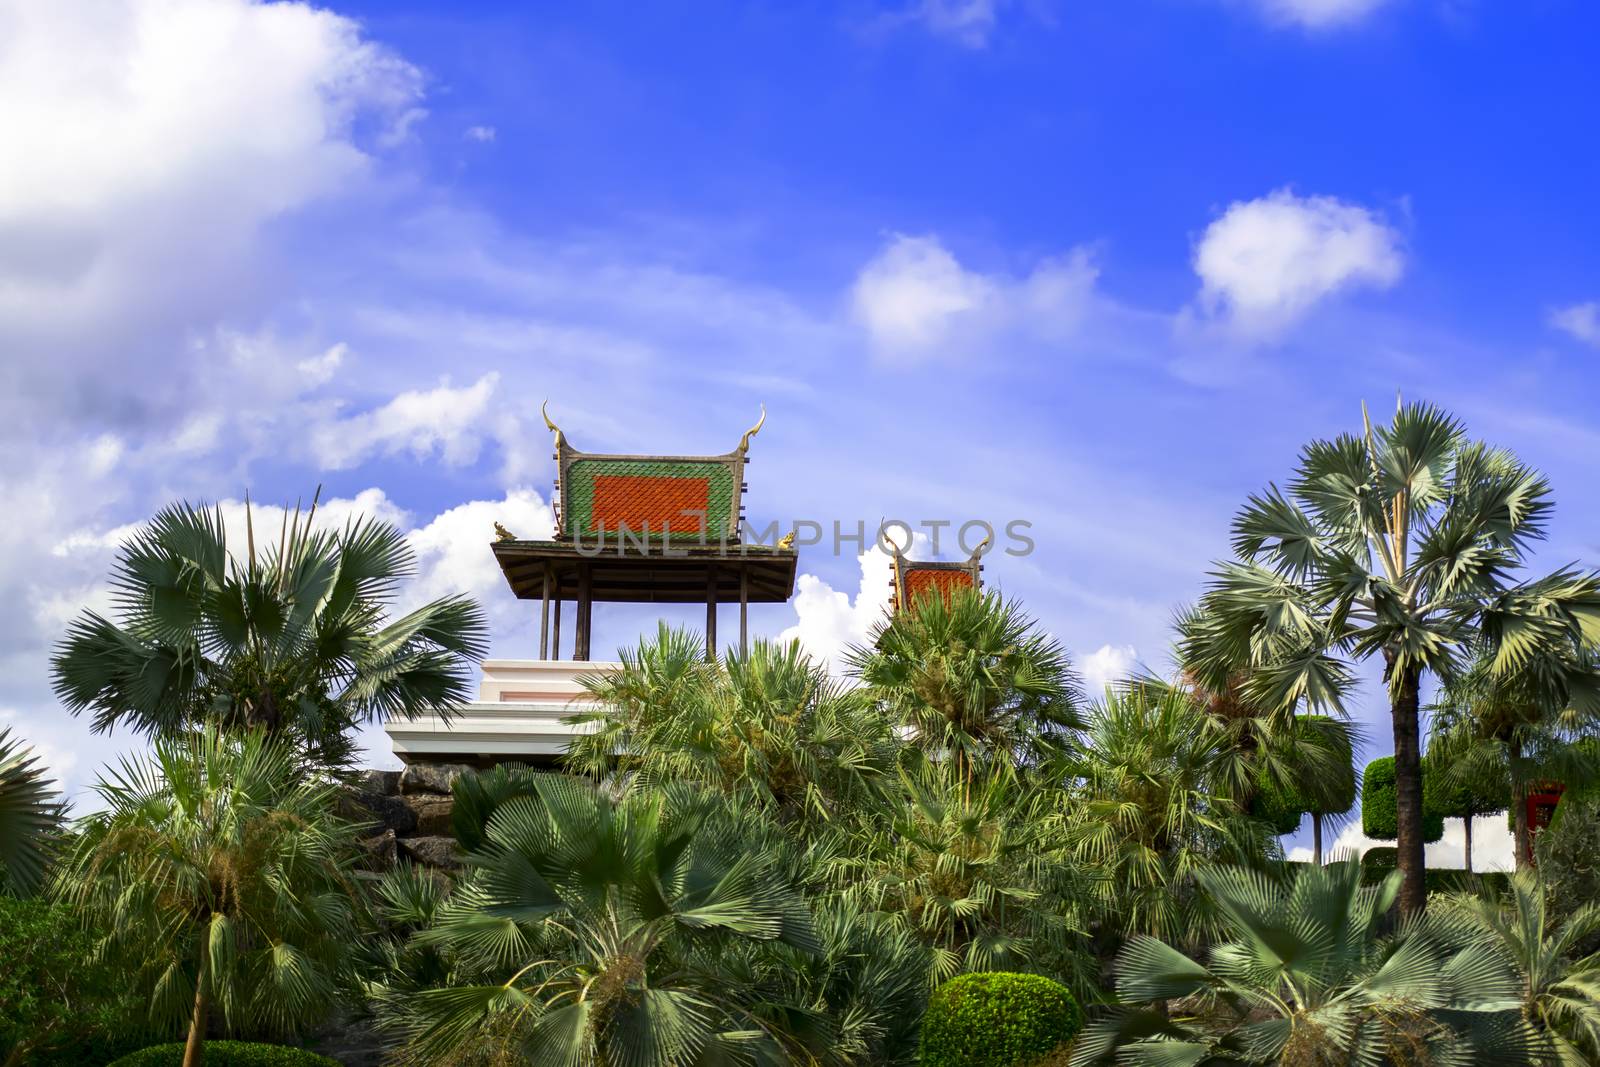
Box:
51;499;486;763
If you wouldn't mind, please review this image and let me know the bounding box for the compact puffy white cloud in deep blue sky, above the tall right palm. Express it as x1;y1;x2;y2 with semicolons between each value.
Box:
1194;189;1405;336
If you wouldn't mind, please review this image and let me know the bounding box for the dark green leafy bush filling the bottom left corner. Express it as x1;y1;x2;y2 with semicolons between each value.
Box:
0;896;134;1064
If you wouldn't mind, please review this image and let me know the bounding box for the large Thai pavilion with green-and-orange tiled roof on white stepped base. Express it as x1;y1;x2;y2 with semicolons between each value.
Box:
384;404;793;766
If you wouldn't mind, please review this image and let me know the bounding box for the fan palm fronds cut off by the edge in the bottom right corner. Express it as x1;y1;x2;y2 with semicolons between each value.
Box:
1461;870;1600;1067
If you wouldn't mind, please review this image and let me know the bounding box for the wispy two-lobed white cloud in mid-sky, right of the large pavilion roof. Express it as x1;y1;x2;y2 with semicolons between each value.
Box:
851;234;1099;360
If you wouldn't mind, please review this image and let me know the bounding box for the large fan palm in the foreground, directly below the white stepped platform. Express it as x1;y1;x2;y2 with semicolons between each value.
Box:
400;774;821;1067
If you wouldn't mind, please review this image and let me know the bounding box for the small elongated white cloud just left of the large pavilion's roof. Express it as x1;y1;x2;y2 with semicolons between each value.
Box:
310;371;499;470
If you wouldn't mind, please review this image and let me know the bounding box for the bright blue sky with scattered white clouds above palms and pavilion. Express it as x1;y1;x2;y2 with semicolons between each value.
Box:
0;0;1600;870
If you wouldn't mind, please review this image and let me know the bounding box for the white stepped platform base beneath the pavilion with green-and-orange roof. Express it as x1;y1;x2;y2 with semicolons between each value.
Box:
384;659;619;765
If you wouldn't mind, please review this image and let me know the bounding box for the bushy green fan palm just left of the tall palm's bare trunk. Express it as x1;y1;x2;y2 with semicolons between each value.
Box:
1059;683;1266;941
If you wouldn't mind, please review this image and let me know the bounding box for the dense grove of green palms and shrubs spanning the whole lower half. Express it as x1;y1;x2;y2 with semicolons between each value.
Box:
0;406;1600;1067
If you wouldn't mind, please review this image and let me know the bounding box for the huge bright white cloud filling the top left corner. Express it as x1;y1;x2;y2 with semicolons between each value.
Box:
0;0;422;419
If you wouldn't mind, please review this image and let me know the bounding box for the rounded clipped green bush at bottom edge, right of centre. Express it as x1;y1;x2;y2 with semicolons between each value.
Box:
922;973;1083;1067
